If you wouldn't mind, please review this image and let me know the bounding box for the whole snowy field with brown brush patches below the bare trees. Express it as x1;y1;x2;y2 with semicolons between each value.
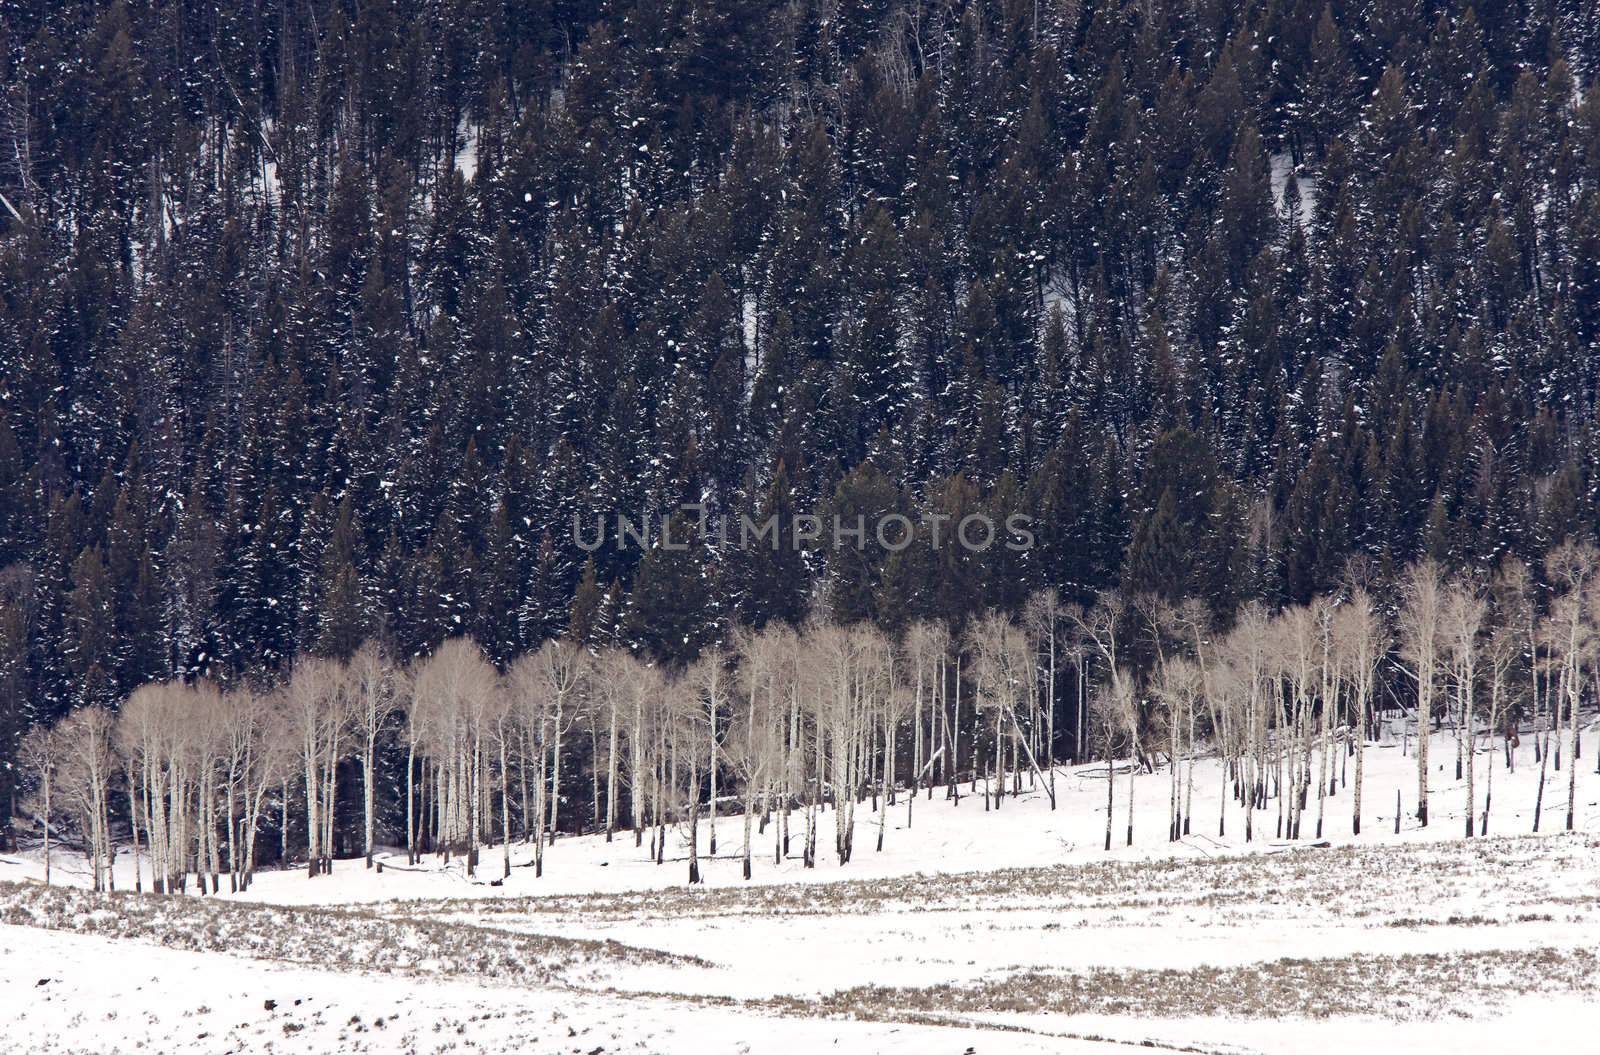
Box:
0;730;1600;1055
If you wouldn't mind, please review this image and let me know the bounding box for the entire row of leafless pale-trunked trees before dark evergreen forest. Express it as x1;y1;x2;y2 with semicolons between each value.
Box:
22;543;1600;893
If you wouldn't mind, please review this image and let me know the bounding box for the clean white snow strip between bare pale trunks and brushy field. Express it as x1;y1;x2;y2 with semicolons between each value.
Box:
12;724;1600;905
